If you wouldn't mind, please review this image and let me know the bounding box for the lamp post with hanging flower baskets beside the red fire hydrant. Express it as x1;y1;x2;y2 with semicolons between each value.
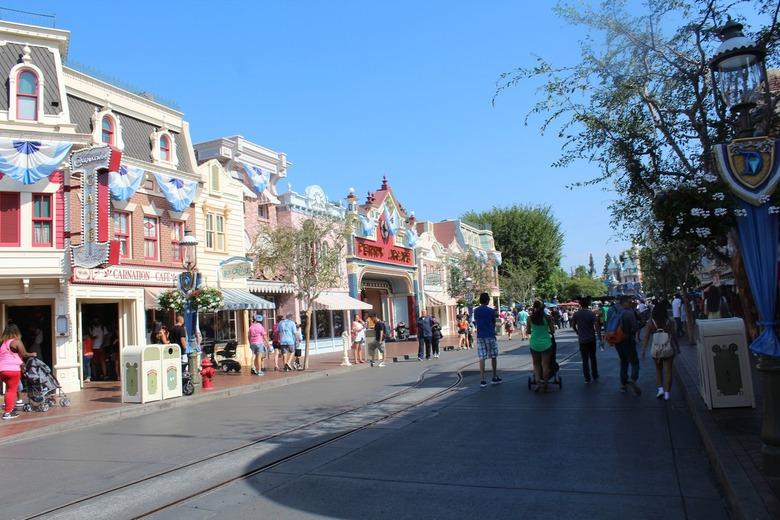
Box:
179;230;201;391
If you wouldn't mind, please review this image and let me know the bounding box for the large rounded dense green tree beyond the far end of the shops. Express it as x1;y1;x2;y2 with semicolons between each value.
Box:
462;205;563;281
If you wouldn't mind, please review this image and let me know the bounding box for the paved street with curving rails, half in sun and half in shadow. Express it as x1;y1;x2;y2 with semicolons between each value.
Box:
0;333;727;519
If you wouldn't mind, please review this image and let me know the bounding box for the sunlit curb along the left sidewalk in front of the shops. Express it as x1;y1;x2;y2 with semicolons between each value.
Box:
0;364;368;446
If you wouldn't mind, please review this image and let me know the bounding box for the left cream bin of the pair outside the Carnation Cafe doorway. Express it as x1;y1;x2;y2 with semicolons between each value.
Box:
122;345;162;403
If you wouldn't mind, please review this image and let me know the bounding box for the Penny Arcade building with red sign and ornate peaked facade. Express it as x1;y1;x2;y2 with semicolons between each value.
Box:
346;178;420;334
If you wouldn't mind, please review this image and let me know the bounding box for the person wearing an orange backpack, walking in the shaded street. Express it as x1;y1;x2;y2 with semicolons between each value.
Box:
606;295;642;396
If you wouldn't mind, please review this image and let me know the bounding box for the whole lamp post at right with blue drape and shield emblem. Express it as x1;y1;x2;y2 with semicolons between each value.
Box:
709;20;780;477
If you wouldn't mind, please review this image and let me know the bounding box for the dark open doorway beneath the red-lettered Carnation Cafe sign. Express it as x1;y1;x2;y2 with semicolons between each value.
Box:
81;302;121;381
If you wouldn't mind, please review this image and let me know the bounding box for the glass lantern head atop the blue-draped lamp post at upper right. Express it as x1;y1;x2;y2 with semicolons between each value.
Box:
710;20;769;137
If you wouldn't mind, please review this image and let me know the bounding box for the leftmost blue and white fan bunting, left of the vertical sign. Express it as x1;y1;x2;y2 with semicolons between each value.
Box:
0;139;72;184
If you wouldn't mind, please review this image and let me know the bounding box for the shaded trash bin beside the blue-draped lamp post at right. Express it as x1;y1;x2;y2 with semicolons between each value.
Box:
696;318;756;410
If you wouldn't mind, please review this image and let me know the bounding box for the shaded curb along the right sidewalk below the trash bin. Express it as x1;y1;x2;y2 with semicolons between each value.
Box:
673;352;772;520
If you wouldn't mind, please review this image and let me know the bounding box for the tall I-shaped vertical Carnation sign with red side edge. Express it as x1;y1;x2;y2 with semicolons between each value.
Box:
70;146;122;268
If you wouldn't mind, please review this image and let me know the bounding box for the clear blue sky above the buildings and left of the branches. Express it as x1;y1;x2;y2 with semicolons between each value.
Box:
7;0;628;272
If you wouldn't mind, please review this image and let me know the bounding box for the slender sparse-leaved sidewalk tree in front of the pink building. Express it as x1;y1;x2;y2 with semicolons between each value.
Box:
251;217;346;370
